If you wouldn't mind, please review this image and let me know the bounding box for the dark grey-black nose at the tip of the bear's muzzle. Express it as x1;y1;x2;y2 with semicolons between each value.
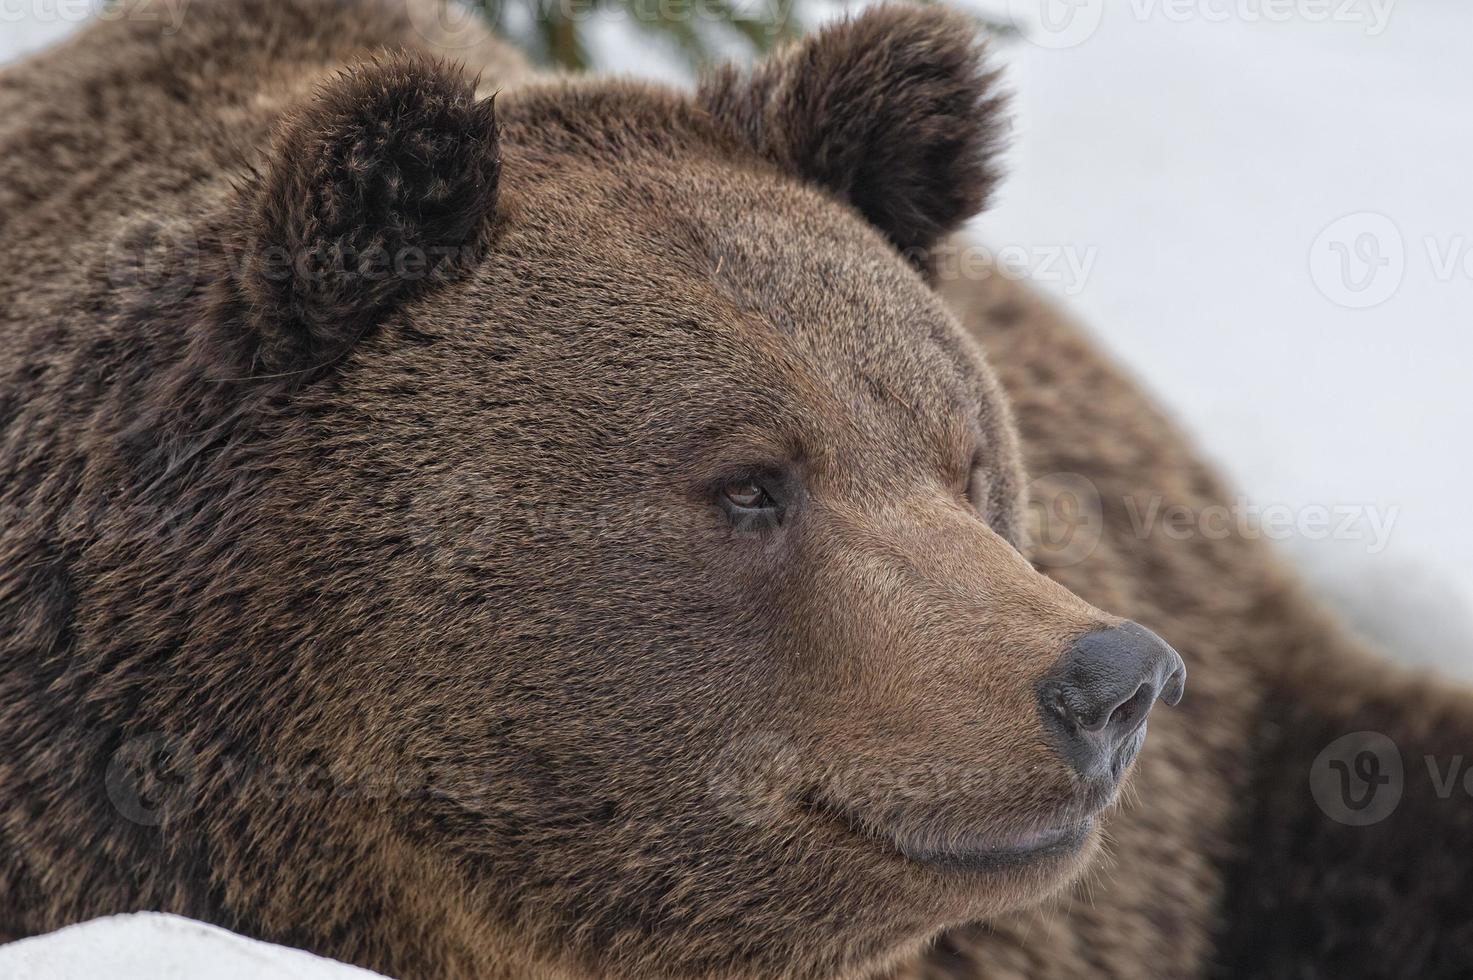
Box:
1038;623;1187;778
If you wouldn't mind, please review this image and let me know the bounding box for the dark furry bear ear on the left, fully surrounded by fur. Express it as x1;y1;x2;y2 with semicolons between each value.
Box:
234;55;501;371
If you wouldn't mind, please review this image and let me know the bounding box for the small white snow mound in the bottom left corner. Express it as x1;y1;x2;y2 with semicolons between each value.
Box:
0;912;380;980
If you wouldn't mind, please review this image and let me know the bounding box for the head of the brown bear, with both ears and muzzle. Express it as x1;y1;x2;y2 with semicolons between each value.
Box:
120;7;1180;977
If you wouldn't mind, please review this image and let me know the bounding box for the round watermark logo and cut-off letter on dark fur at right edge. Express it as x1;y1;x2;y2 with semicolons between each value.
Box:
1309;731;1473;827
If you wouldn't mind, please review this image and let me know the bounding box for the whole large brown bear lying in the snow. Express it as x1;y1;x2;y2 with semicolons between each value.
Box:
0;0;1473;980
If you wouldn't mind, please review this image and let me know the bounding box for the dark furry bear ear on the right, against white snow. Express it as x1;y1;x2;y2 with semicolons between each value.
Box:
697;6;1005;267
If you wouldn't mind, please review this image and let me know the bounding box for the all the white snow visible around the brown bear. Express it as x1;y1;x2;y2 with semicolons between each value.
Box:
0;0;1473;980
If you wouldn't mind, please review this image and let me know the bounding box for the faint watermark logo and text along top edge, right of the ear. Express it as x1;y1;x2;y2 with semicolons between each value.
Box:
1008;0;1396;49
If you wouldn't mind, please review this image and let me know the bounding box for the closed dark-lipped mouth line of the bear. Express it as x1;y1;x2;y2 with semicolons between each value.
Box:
803;793;1094;872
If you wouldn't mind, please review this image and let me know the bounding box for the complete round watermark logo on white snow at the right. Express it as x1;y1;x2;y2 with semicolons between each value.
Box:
1309;211;1407;309
